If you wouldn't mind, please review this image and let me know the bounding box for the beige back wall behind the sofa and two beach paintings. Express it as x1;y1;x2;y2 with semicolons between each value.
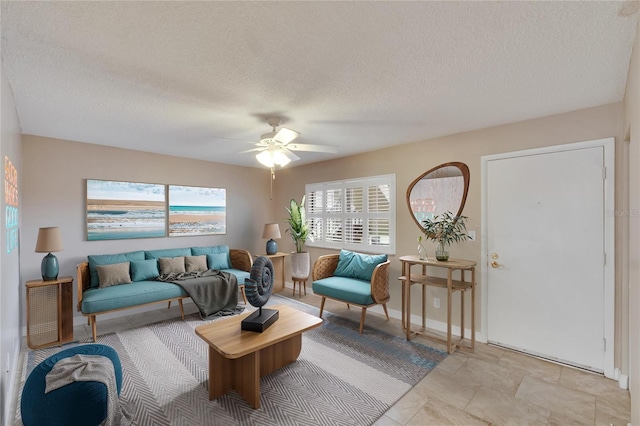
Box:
21;135;274;323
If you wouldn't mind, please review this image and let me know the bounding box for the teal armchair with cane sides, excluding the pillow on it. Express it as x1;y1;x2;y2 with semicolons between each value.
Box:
311;254;391;334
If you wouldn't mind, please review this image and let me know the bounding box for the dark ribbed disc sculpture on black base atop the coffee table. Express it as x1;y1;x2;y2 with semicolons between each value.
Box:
241;256;279;333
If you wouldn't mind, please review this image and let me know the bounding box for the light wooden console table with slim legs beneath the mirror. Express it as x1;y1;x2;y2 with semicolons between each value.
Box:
398;256;476;353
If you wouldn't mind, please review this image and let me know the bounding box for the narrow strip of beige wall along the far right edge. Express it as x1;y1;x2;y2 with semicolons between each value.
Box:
623;11;640;425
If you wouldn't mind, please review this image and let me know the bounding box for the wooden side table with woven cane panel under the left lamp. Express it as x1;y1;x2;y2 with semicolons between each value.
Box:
25;277;73;349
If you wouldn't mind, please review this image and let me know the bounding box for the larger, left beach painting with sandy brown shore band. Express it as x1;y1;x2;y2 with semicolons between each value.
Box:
87;179;167;241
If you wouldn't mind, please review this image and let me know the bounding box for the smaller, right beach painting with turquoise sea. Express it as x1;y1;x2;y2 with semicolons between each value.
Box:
169;185;227;237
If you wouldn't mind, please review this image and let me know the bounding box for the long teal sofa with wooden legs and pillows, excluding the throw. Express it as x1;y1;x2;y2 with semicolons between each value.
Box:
76;245;253;342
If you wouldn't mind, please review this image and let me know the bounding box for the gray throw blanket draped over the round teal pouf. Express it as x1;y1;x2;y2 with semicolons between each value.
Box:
44;354;133;426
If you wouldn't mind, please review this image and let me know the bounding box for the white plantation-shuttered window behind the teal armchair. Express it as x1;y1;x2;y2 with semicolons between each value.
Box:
305;175;396;254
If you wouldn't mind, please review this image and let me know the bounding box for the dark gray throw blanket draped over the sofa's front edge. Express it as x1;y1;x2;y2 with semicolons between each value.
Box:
156;269;244;319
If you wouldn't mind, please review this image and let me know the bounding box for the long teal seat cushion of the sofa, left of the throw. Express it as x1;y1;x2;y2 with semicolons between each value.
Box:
82;281;188;314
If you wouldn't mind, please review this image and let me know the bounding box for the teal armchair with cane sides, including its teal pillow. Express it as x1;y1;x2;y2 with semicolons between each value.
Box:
311;250;391;334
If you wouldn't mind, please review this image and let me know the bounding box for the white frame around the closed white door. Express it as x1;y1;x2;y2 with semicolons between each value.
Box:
478;137;615;379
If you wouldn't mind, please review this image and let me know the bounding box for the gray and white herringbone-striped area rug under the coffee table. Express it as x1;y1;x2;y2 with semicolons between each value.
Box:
17;295;447;426
